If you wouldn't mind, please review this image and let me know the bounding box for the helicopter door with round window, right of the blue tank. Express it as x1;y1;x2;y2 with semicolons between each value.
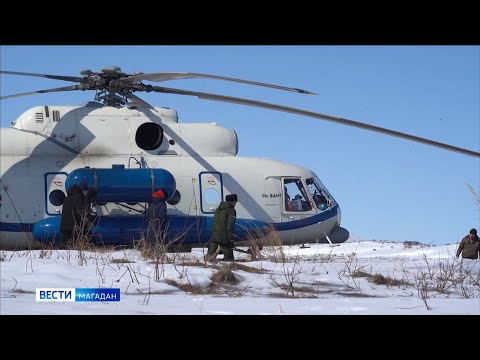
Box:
199;172;223;214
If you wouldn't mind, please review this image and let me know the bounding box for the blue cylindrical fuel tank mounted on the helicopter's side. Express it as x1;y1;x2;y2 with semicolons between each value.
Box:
65;165;176;203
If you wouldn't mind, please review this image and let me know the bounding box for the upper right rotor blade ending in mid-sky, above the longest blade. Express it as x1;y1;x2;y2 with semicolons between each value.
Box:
121;72;316;95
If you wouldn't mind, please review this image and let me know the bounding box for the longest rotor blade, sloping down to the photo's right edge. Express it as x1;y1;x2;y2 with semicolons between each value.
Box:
147;86;480;157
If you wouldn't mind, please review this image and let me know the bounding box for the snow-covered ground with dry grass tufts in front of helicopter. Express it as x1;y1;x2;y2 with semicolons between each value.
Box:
0;241;480;315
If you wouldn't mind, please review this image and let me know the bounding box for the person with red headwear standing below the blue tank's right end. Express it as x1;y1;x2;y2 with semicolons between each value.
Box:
145;189;167;243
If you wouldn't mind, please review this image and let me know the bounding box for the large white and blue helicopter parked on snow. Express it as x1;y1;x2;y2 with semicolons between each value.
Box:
0;66;480;251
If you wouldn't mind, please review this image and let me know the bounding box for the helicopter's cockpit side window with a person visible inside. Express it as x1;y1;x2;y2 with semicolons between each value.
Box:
282;178;315;222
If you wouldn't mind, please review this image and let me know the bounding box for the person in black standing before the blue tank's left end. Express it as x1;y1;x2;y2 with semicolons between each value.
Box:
60;183;96;243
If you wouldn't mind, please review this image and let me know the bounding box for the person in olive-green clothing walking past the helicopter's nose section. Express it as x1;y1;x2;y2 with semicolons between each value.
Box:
205;194;238;261
